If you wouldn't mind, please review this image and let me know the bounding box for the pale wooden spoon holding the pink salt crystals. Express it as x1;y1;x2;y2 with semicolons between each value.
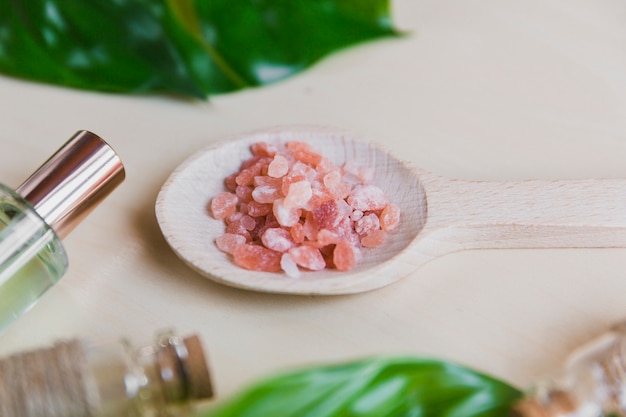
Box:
156;127;626;294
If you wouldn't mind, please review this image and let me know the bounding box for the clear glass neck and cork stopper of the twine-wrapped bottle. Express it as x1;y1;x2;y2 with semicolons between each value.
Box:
88;333;212;417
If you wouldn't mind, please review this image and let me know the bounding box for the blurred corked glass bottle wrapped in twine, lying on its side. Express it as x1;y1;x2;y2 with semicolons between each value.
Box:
0;332;213;417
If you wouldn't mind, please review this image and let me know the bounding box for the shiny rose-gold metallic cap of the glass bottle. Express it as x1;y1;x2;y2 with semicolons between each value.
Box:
16;130;125;239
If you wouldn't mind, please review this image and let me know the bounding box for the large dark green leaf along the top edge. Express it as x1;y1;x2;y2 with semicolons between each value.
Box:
0;0;397;98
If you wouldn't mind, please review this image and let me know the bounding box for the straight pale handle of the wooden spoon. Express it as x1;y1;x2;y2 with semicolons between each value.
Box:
424;178;626;249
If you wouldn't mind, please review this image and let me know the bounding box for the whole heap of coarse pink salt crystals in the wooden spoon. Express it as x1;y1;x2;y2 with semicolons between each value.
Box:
210;141;400;272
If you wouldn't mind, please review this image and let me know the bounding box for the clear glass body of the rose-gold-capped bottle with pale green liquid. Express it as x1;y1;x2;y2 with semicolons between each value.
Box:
0;184;67;334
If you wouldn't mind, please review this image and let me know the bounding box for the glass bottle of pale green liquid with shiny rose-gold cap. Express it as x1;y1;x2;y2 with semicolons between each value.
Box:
0;131;124;334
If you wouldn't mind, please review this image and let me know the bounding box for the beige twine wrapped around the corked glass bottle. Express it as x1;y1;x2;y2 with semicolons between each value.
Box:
0;340;94;417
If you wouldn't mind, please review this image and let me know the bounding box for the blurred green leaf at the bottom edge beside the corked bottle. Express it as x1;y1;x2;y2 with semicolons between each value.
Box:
203;358;521;417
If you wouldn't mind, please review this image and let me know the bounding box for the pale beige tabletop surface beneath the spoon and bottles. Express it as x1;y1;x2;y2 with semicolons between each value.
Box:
0;0;626;402
